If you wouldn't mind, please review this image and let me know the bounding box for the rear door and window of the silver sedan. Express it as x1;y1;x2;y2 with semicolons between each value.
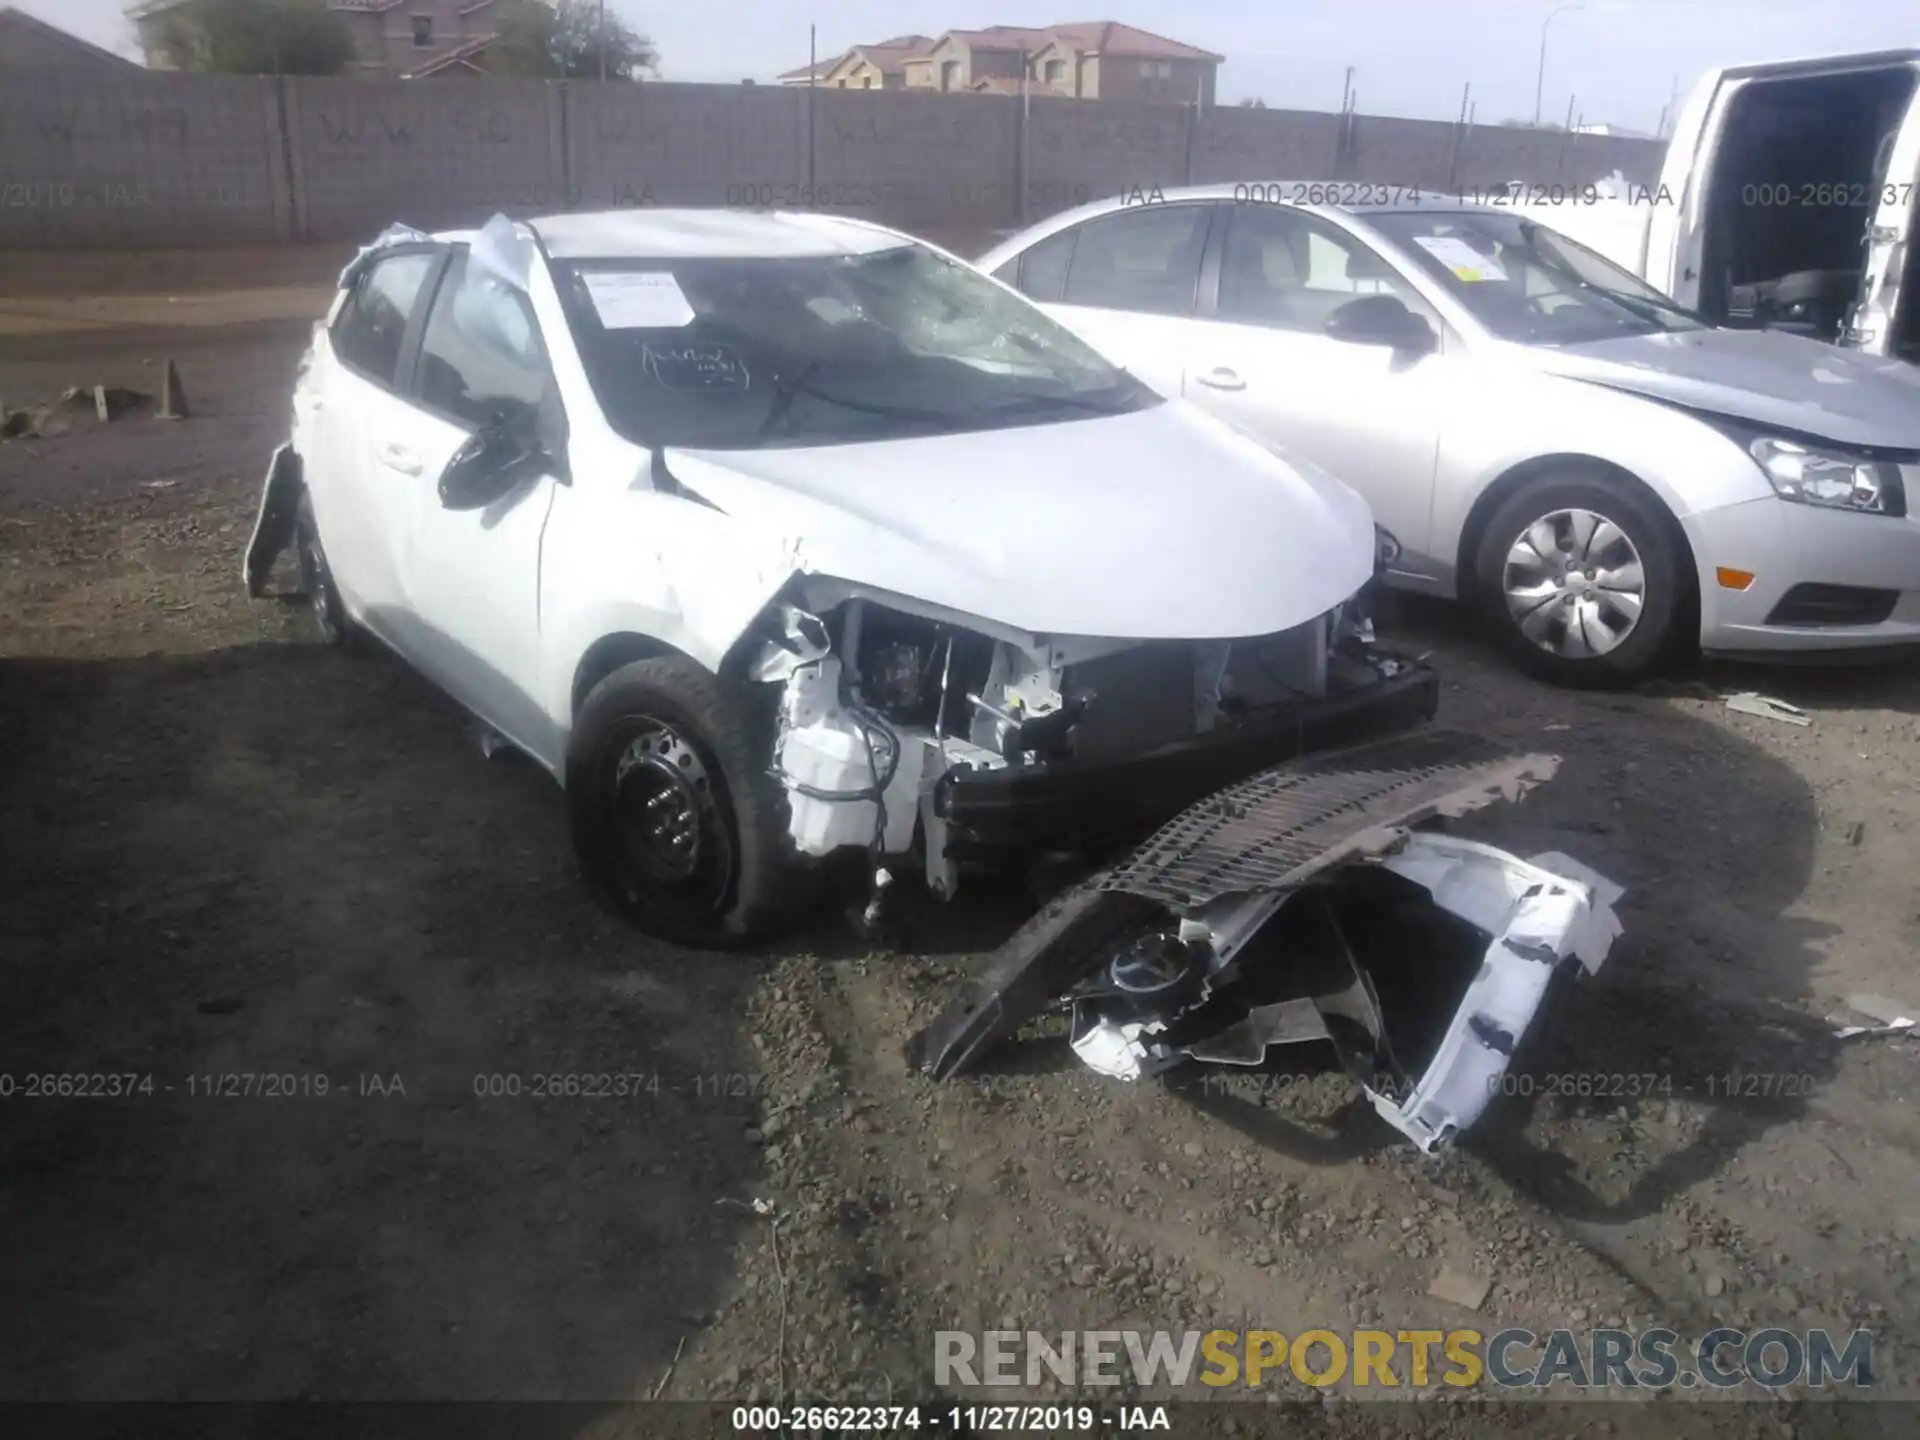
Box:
1002;202;1215;396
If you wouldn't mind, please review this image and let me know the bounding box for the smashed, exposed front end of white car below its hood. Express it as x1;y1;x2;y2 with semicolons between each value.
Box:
741;532;1438;899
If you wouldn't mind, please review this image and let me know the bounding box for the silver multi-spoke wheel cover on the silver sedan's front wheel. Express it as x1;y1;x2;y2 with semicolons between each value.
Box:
1501;509;1647;660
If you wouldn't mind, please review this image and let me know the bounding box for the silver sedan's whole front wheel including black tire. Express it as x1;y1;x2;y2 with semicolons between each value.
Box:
1473;470;1688;687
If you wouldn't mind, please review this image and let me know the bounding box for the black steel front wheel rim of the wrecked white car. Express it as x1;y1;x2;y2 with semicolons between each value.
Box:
612;716;735;910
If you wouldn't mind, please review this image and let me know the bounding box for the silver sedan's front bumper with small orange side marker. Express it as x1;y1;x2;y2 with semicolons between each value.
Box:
1684;495;1920;660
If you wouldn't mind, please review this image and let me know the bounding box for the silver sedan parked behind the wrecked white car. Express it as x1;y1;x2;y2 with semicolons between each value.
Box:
977;182;1920;684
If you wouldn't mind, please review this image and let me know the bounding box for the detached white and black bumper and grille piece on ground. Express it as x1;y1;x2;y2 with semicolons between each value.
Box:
908;730;1620;1152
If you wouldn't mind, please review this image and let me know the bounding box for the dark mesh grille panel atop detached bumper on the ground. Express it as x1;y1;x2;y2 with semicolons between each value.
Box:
1102;730;1559;910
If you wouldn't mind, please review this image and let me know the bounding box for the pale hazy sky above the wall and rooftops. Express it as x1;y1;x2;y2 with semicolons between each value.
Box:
26;0;1920;131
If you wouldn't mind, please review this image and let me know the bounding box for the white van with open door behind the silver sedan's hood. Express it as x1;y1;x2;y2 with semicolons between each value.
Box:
1513;50;1920;363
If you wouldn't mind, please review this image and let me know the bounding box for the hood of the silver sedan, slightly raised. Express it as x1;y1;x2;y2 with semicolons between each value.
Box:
1528;330;1920;449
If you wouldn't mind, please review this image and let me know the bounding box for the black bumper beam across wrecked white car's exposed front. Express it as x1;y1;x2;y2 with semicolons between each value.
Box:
933;660;1440;858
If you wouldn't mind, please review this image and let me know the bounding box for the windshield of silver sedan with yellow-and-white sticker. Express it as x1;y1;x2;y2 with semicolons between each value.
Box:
1367;211;1709;346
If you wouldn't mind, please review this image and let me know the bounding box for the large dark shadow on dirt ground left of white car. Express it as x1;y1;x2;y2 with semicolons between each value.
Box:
0;645;760;1428
